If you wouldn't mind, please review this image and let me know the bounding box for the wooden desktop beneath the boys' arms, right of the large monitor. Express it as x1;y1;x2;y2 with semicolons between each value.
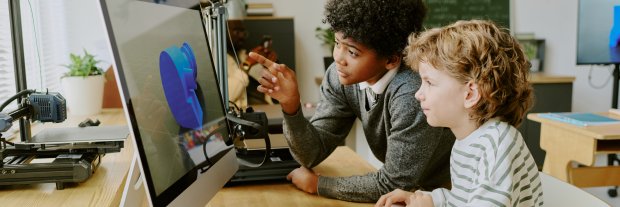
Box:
207;146;376;207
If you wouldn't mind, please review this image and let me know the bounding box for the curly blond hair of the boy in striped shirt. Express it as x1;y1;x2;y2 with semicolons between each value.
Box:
405;20;533;126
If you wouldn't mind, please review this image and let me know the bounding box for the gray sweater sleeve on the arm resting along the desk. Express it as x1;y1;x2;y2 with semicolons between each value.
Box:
318;89;451;202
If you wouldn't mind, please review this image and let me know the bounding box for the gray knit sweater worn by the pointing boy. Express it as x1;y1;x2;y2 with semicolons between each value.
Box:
284;64;454;202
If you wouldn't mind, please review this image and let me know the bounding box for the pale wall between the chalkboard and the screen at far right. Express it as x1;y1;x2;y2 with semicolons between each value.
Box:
513;0;612;112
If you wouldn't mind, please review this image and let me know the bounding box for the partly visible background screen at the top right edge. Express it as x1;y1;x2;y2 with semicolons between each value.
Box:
577;0;620;65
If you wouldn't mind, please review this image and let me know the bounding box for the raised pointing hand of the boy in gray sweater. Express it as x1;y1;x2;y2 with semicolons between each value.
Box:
249;52;301;114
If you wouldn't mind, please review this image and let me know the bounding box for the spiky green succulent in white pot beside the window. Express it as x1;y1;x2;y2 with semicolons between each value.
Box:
60;50;105;115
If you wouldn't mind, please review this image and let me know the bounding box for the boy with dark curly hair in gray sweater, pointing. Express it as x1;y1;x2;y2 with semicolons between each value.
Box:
250;0;454;202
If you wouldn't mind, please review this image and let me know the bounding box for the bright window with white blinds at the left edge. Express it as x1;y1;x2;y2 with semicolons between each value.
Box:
0;0;68;111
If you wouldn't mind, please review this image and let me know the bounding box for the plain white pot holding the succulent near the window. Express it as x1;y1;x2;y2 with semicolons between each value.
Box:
60;75;105;116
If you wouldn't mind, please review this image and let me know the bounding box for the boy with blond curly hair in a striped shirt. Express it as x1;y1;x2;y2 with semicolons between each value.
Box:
376;20;543;207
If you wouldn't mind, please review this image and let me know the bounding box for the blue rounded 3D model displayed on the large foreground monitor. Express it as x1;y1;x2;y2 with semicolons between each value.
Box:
159;43;203;129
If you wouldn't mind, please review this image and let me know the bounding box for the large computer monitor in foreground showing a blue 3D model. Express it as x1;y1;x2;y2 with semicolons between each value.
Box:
100;0;238;206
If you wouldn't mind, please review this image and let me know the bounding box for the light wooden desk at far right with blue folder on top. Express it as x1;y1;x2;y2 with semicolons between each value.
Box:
527;113;620;187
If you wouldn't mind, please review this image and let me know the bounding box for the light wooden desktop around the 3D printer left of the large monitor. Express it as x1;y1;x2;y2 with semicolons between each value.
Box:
0;109;134;206
